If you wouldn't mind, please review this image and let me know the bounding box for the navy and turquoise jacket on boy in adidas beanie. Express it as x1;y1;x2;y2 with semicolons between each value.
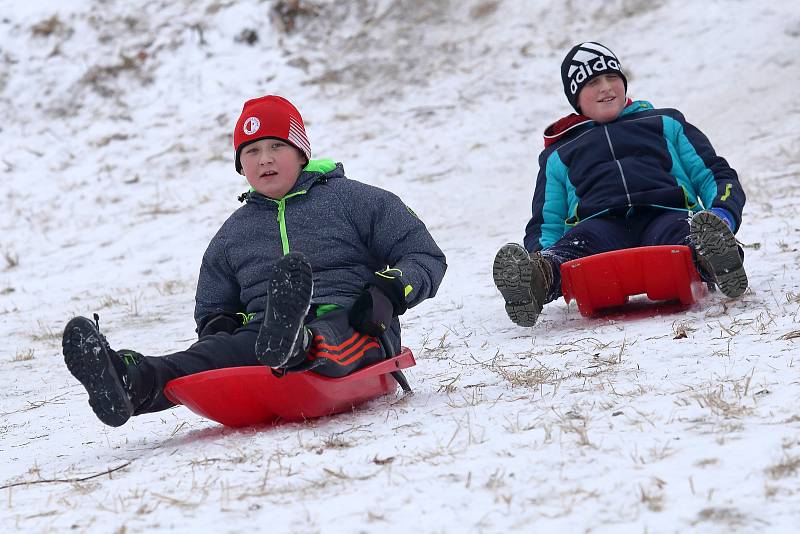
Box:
525;101;745;252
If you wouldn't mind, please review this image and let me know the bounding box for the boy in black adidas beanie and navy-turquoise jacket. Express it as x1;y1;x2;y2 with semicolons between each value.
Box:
493;41;747;326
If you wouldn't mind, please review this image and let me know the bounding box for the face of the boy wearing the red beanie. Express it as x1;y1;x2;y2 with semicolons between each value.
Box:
239;139;306;199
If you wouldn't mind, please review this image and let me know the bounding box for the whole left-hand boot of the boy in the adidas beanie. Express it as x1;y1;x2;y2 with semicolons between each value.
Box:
492;243;553;326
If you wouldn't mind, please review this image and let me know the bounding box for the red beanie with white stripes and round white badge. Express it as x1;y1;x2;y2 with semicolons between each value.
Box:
233;95;311;174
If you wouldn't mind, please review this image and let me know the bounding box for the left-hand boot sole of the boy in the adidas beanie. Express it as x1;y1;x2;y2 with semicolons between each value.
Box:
492;243;542;326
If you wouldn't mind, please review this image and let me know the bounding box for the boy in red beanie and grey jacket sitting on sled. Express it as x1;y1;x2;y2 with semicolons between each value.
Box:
63;95;447;426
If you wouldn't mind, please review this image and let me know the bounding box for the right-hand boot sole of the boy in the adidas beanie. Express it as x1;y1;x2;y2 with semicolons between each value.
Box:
690;212;748;298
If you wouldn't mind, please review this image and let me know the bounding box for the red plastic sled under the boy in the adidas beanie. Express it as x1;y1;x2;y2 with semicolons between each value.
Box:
561;245;706;317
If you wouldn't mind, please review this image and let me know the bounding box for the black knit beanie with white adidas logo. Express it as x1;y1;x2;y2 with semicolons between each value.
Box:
561;41;628;113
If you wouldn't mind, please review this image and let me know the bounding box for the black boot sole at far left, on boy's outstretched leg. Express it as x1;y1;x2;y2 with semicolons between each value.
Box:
61;317;133;427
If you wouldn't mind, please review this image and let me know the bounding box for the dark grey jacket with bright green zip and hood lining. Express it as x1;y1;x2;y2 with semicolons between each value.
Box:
194;160;447;339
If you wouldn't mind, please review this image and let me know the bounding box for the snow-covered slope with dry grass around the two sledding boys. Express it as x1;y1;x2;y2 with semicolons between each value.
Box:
0;0;800;533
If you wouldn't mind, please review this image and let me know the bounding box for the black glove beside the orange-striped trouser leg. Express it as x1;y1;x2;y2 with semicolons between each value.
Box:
348;269;408;336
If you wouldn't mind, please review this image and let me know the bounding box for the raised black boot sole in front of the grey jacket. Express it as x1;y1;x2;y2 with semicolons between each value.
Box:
255;252;314;368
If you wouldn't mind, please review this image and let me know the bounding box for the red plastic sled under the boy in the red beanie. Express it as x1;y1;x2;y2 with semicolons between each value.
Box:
164;347;416;427
